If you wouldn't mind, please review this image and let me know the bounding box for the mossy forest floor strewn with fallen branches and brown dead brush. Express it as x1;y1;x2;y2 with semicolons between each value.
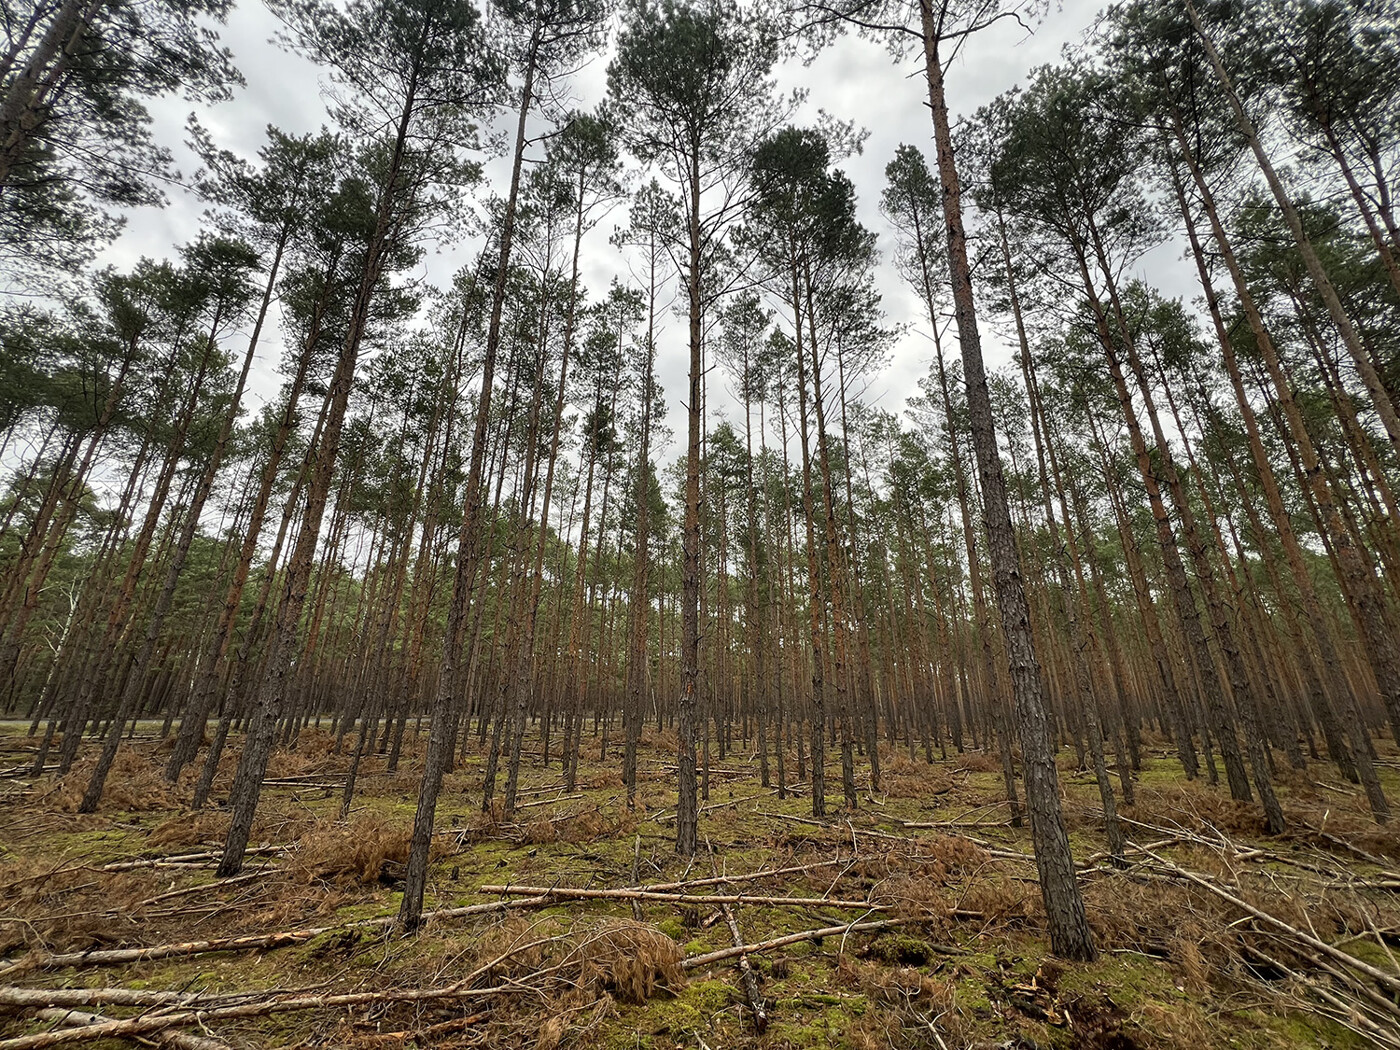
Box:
0;727;1400;1050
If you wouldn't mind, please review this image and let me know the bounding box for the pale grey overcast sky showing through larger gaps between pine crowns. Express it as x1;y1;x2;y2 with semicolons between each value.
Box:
109;0;1186;461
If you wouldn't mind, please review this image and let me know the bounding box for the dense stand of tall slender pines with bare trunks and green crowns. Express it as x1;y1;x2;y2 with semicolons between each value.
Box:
0;0;1400;958
